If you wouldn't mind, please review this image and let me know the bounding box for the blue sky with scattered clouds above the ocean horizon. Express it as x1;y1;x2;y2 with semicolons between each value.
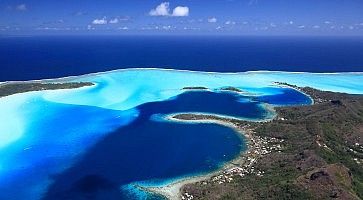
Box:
0;0;363;36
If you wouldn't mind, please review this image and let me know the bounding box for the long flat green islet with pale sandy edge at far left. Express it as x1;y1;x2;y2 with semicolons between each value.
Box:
0;82;94;98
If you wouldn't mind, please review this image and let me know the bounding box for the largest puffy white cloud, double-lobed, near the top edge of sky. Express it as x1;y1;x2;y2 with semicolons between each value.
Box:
149;2;189;17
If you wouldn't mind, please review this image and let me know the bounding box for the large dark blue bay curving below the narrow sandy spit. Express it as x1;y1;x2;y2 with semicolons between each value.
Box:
44;122;242;199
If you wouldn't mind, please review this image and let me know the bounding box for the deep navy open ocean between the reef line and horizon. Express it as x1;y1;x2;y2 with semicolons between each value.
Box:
0;36;363;81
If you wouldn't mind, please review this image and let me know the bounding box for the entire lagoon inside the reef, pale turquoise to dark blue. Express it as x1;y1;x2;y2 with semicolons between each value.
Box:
0;69;363;199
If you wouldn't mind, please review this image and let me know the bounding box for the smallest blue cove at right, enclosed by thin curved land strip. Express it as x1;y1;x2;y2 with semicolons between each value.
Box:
254;88;313;106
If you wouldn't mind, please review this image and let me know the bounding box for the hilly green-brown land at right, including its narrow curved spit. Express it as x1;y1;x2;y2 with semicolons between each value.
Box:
170;83;363;200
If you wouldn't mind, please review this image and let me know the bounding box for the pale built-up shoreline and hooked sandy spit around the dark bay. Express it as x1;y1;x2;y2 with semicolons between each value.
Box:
144;113;282;200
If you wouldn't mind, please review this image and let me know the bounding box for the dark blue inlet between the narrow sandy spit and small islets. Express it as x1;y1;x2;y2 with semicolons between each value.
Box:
140;91;270;119
